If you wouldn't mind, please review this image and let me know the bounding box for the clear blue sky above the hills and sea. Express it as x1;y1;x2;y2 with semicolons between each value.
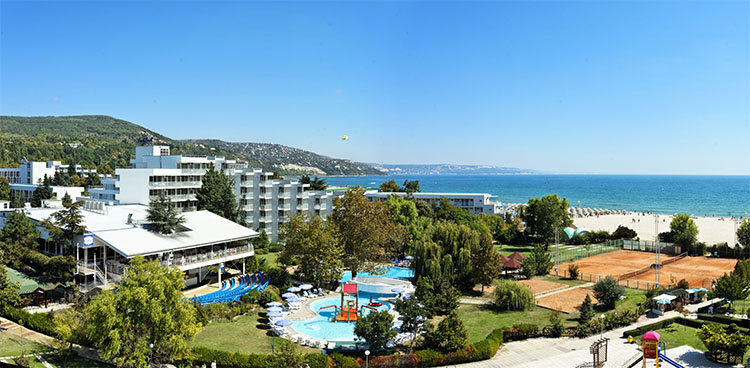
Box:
0;0;750;175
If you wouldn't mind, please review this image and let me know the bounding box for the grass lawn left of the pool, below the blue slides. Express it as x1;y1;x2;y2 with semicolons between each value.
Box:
189;313;319;354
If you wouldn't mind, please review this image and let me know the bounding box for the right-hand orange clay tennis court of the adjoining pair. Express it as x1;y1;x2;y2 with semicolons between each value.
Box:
621;257;737;289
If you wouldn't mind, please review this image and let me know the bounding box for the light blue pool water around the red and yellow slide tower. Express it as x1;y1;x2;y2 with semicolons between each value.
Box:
292;292;392;342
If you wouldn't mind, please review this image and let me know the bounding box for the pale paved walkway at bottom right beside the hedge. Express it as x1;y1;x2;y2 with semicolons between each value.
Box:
450;311;679;368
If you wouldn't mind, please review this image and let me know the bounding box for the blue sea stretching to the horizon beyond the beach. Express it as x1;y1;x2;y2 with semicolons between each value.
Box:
326;175;750;216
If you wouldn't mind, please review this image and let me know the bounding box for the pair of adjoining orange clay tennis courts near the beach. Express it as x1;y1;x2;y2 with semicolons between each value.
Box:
560;250;737;289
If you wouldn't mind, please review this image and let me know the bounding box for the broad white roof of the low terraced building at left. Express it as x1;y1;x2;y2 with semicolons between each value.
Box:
27;204;258;257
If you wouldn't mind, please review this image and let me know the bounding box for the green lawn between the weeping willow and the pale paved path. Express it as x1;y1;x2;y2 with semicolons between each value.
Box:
458;304;576;343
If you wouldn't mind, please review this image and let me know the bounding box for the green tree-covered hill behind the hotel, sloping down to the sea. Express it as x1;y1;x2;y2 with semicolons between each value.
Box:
0;115;381;175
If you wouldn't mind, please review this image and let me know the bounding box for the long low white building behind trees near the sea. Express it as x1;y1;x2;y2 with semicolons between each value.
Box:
365;190;504;215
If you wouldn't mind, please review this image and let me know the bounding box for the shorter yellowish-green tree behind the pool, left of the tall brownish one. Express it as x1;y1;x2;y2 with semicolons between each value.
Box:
279;214;343;285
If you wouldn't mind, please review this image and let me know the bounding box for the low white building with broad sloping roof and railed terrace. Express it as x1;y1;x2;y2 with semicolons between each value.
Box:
0;201;258;289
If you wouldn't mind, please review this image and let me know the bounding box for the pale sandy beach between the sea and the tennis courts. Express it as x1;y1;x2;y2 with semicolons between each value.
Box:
573;213;734;246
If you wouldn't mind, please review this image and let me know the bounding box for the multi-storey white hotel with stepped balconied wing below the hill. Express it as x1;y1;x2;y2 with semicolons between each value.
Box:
89;146;333;241
